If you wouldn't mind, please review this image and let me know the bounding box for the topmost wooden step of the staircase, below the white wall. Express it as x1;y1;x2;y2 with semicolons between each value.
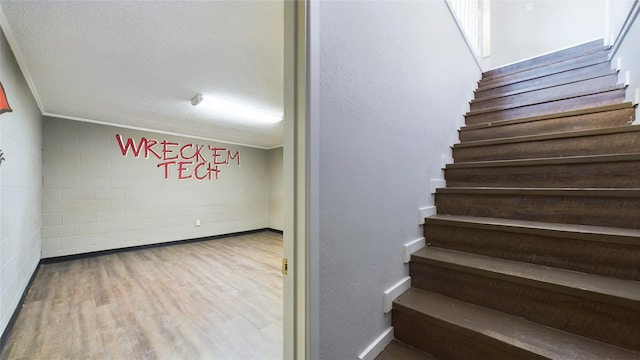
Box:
482;40;609;79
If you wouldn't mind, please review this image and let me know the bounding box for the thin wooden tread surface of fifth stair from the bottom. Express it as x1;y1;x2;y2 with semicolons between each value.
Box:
445;153;640;169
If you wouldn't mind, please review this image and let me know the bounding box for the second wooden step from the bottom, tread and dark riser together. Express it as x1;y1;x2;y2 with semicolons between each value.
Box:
410;247;640;351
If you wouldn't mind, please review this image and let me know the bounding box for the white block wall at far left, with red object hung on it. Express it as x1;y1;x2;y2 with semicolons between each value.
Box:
0;31;42;333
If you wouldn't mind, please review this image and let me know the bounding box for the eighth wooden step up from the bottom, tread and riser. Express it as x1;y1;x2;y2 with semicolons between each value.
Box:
465;86;625;125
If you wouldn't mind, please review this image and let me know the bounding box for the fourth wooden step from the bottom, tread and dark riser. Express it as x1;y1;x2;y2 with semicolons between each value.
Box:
435;188;640;229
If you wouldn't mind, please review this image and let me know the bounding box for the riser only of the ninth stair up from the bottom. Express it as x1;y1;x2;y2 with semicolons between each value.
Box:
470;74;618;111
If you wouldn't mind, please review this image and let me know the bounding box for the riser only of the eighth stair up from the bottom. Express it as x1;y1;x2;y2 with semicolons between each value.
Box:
465;89;625;125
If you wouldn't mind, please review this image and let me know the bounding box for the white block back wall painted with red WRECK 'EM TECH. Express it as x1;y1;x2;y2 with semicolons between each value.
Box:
42;117;270;258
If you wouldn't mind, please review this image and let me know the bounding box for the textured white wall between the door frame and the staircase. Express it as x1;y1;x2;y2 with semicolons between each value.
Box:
308;1;480;359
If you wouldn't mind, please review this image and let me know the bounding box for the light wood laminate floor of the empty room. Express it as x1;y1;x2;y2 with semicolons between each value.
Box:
2;231;282;360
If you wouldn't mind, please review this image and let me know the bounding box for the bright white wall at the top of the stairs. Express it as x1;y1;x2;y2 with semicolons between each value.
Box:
482;0;605;70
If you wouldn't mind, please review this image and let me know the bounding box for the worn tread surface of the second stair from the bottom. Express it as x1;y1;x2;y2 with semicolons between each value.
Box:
411;246;640;309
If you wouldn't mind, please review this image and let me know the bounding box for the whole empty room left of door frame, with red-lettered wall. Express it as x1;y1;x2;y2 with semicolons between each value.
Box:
0;1;283;359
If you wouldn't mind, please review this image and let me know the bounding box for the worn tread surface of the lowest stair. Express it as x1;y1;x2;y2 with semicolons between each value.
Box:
393;288;640;359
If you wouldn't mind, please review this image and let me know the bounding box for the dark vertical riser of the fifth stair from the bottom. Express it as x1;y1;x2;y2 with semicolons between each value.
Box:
444;161;640;188
